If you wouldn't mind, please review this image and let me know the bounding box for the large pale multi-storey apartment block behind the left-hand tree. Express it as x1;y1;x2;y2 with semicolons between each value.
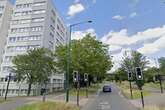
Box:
0;0;67;96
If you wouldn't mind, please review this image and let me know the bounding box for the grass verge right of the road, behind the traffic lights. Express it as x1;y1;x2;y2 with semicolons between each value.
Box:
118;81;150;99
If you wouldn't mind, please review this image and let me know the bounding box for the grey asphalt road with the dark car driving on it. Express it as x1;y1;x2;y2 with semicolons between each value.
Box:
82;84;137;110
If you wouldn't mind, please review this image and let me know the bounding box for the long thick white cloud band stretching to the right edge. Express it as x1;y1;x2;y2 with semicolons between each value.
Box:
101;26;165;46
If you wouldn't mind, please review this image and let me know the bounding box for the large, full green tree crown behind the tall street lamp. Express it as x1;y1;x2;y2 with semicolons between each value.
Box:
55;34;112;84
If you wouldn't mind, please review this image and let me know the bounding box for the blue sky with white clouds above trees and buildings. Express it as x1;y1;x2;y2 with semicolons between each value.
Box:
10;0;165;72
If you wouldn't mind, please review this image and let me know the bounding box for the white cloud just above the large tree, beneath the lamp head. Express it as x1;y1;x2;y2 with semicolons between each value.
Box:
72;28;96;40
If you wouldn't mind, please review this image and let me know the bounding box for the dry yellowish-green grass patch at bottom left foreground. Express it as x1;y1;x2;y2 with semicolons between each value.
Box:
16;102;80;110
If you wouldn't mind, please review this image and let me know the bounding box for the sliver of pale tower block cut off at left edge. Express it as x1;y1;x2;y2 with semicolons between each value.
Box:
0;0;13;70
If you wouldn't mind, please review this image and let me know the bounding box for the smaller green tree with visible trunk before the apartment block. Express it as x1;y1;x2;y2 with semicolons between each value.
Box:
12;48;55;96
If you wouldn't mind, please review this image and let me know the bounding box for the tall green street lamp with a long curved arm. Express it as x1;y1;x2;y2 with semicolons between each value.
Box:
65;21;92;102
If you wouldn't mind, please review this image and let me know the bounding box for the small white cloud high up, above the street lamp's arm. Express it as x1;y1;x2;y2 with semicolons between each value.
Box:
68;3;85;16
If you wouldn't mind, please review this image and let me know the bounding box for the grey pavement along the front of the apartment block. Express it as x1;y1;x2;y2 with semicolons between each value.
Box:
0;93;88;110
